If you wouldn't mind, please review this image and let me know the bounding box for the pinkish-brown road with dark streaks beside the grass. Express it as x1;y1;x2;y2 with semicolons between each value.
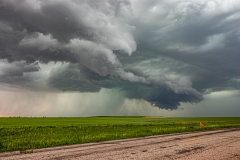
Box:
0;128;240;160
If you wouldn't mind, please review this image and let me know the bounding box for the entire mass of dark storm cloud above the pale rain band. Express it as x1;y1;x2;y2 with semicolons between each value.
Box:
0;0;240;109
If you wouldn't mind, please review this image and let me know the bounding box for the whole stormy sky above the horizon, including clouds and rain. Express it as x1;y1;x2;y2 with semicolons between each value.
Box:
0;0;240;116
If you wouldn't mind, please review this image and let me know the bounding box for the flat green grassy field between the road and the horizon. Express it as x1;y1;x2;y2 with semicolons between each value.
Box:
0;117;240;152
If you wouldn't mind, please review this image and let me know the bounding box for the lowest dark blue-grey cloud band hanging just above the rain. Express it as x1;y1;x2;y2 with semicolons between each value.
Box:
48;65;202;109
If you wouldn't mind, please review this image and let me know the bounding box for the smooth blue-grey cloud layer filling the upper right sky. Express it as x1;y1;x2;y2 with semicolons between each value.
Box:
128;0;240;93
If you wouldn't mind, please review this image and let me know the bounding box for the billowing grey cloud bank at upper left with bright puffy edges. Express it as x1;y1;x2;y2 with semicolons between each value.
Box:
1;0;146;83
